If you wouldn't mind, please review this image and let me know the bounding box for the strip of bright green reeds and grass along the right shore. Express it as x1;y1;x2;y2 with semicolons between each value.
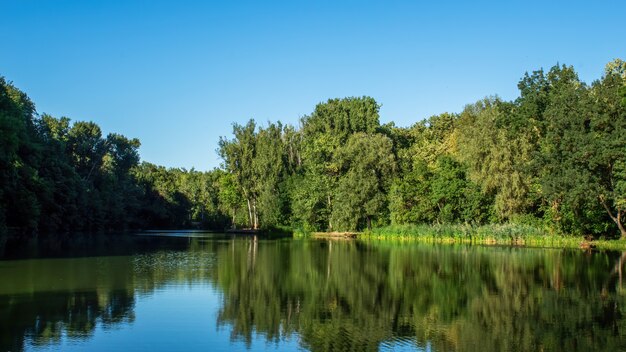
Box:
358;224;626;250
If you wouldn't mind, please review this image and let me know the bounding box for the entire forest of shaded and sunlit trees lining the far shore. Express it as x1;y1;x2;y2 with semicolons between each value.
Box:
0;59;626;238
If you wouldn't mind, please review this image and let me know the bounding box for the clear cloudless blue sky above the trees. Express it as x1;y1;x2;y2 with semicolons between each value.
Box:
0;0;626;170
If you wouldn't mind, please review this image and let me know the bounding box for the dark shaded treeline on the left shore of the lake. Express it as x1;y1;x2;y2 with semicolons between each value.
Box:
0;77;228;236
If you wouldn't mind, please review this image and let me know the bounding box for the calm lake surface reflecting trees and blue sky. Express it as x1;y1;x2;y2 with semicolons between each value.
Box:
0;234;626;352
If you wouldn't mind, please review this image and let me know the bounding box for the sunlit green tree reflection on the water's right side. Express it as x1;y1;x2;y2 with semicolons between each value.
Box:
215;241;626;351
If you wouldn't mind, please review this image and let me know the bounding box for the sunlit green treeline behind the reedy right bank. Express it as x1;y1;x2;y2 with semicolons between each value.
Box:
219;60;626;237
